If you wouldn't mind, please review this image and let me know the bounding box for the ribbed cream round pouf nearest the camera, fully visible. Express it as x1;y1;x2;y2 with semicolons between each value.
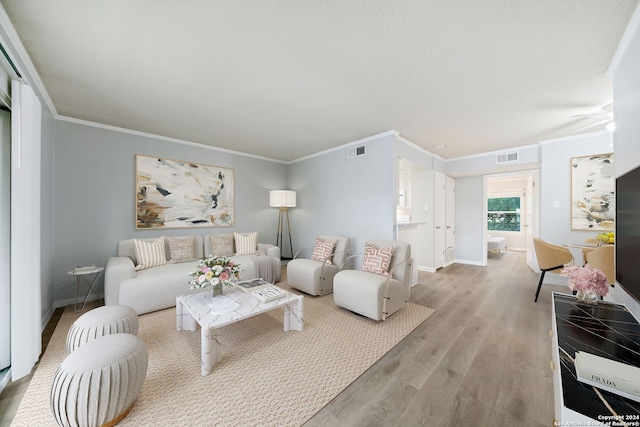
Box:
50;334;149;427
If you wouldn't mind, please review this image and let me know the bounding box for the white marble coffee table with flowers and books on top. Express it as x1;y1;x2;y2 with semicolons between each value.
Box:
176;289;304;376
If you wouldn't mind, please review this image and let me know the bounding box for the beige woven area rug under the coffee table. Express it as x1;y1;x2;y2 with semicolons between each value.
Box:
12;295;433;427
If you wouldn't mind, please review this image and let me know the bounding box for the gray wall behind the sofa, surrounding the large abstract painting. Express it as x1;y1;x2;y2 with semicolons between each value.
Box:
50;120;287;304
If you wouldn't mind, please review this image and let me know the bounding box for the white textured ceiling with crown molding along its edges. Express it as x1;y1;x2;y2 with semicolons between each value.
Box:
0;0;638;161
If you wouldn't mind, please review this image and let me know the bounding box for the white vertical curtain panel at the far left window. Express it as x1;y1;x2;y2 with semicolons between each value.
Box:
11;80;42;381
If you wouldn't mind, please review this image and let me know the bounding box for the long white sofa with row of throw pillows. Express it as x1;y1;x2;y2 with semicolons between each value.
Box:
104;234;282;315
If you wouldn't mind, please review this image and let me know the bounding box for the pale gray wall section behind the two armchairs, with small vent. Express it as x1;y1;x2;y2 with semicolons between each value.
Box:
288;134;396;260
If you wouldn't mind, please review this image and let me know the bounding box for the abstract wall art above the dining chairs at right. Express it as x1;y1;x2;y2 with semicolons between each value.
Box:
571;153;616;231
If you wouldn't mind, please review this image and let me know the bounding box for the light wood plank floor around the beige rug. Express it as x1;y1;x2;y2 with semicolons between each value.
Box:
0;252;567;427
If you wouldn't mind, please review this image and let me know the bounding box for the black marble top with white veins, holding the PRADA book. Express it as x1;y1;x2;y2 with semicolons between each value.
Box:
554;293;640;425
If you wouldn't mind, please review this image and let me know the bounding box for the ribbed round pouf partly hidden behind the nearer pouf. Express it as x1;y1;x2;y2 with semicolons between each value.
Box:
67;305;138;353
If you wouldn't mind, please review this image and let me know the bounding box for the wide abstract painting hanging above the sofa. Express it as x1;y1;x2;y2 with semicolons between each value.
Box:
136;154;235;229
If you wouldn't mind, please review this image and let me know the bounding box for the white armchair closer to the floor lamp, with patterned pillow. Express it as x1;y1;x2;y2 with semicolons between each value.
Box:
287;235;351;295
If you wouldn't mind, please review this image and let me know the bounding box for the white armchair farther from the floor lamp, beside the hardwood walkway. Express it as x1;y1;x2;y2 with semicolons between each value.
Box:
333;240;413;320
